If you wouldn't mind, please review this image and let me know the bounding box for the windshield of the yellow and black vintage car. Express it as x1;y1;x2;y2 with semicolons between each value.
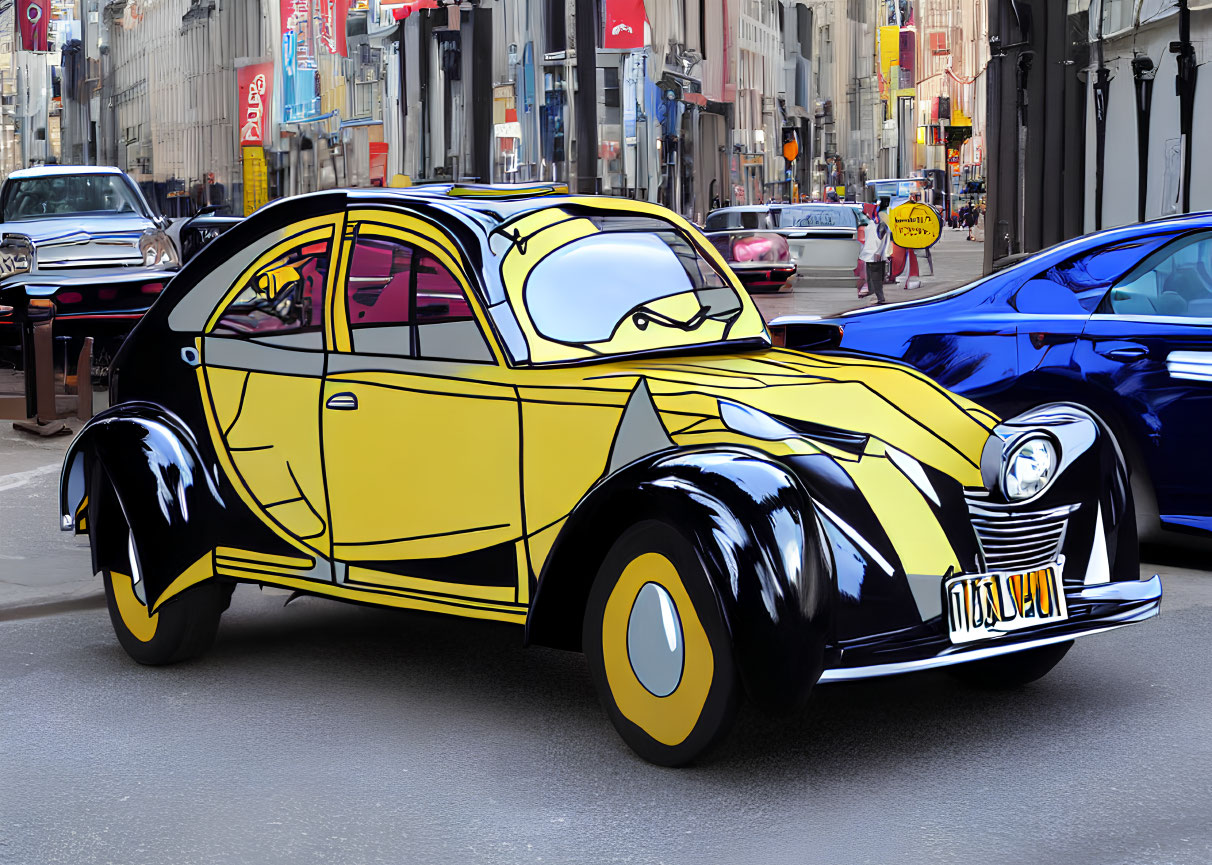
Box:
513;216;765;360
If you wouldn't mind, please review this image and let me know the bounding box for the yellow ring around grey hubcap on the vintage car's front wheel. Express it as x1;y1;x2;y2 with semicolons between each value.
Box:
602;552;715;746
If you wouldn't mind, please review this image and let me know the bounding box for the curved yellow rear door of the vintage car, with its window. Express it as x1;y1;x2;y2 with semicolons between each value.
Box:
199;217;342;554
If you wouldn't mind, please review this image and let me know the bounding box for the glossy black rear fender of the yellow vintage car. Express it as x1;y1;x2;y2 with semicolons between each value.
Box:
59;402;227;603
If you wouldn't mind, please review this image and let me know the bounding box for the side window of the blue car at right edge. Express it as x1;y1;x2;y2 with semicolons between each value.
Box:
1098;231;1212;319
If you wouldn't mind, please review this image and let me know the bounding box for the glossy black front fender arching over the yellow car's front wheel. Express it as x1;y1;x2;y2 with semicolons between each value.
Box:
526;448;834;711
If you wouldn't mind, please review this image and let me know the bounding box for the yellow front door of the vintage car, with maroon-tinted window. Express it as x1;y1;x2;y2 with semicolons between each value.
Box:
321;210;528;611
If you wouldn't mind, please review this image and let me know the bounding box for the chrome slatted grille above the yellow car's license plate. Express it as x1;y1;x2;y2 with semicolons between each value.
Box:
968;495;1077;573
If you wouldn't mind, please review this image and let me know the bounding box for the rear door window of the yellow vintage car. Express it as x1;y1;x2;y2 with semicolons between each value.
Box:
211;239;331;348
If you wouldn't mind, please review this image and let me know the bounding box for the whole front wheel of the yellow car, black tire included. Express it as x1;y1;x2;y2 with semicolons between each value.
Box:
582;521;741;766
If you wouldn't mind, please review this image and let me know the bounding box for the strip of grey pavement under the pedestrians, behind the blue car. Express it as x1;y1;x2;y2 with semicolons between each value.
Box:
754;228;984;321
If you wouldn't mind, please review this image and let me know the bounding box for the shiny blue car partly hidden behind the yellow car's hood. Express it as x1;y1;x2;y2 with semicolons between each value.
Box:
772;213;1212;539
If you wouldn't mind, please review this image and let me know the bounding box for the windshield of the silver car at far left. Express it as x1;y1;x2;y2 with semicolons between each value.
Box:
4;174;148;222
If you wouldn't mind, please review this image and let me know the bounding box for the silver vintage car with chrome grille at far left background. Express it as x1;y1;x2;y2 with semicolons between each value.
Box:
0;165;179;279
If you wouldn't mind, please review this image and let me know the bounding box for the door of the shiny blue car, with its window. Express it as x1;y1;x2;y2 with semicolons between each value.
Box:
1075;225;1212;531
